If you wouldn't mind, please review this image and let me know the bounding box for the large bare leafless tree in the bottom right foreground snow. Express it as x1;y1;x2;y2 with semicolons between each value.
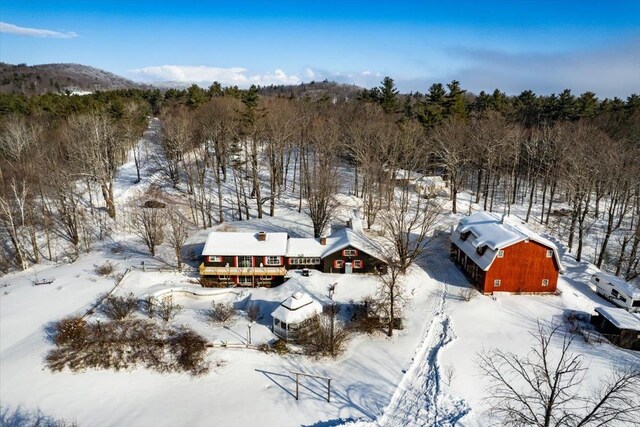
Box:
478;324;640;427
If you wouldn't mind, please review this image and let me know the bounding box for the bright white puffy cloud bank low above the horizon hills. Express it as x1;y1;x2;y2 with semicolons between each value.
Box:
131;65;301;87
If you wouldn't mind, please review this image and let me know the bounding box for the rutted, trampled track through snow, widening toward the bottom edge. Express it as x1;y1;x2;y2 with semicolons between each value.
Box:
374;284;469;427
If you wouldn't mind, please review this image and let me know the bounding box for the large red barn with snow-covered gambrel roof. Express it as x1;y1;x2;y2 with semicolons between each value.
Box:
451;212;562;294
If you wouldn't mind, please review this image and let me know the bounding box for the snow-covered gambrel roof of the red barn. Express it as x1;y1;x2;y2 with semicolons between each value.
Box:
451;212;563;271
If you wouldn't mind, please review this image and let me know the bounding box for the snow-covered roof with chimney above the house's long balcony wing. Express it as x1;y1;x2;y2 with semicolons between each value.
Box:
202;231;287;256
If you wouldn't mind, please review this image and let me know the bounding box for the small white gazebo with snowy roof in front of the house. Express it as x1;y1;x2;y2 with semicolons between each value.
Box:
271;291;322;341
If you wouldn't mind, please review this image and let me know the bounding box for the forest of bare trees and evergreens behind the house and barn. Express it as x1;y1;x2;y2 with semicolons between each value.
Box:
0;78;640;279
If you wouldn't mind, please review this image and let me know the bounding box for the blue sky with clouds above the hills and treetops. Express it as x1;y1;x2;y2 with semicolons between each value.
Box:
0;0;640;97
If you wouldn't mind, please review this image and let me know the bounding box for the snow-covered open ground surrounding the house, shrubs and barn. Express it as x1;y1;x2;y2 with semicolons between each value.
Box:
0;121;640;427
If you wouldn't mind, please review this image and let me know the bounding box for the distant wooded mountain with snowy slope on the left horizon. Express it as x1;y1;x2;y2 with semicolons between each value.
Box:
0;62;146;95
